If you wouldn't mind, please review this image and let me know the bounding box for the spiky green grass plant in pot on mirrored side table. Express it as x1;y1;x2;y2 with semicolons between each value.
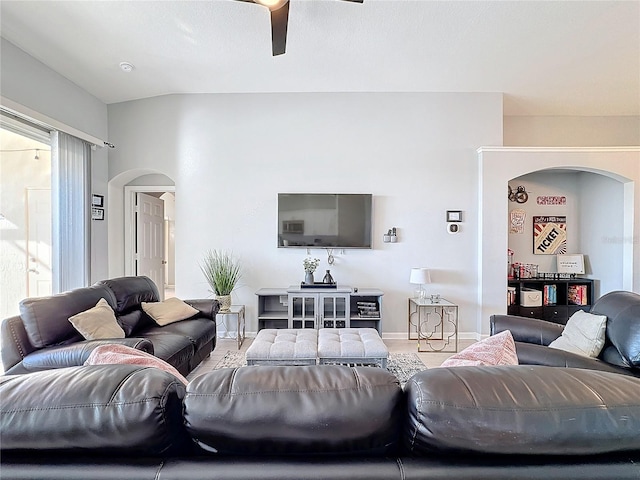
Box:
200;250;240;313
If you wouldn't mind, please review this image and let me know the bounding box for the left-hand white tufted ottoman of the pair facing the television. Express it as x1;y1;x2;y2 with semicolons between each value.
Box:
247;328;318;365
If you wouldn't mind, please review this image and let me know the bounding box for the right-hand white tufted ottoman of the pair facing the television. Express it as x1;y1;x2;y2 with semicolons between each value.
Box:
318;328;389;368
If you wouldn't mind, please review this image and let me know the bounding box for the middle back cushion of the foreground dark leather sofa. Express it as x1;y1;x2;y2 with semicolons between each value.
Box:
185;365;402;455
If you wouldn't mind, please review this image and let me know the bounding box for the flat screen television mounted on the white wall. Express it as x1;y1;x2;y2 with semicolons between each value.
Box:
278;193;373;248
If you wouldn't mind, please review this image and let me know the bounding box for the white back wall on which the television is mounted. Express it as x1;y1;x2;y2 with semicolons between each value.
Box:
109;93;502;338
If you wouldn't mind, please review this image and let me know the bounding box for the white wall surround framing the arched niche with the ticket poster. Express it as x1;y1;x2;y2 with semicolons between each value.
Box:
477;147;640;335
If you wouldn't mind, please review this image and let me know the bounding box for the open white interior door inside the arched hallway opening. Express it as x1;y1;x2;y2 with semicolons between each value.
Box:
136;192;165;300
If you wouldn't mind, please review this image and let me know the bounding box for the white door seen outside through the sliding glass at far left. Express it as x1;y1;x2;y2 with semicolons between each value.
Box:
26;188;52;297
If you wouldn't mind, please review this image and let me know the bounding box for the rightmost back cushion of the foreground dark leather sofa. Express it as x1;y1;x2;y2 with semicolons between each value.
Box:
403;366;640;455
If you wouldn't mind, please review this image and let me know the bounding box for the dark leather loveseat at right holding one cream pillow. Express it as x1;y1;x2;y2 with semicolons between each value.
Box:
490;291;640;377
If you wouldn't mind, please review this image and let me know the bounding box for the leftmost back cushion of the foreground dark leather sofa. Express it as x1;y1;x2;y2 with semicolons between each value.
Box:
0;365;190;456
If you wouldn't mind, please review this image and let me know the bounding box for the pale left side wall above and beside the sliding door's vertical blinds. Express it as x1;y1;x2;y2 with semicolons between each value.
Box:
0;38;108;281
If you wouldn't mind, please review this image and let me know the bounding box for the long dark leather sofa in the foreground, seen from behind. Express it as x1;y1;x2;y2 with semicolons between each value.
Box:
0;365;640;480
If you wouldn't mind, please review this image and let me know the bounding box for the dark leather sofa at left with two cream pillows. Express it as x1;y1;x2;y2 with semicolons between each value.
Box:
0;276;219;375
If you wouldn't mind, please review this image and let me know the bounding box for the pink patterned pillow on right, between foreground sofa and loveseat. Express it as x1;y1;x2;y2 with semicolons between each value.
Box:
440;330;518;367
